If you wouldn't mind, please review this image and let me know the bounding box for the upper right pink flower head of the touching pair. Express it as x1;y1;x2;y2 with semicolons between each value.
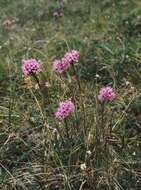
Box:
64;50;80;64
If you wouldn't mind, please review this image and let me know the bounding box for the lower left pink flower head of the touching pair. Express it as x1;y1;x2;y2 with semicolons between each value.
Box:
53;58;69;74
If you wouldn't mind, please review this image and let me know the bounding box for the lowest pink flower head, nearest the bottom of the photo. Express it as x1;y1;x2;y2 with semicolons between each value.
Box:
55;100;75;120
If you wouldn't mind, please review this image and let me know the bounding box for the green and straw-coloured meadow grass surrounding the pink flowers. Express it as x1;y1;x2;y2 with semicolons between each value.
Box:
0;0;141;190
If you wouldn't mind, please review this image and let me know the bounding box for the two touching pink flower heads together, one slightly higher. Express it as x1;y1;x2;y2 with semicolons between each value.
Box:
53;50;80;74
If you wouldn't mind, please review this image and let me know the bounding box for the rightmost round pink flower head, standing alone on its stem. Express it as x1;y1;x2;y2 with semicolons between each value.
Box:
98;86;116;102
